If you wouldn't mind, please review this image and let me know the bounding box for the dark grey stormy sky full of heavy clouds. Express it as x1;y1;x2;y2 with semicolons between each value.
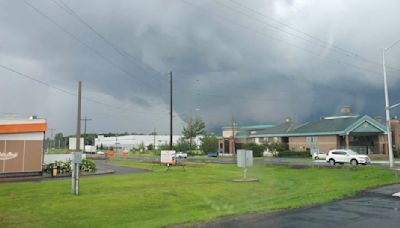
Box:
0;0;400;134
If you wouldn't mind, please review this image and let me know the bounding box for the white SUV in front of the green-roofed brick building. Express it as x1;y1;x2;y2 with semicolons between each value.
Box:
326;149;370;165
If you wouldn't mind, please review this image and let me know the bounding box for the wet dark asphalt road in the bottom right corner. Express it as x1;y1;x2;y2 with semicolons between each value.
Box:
197;184;400;228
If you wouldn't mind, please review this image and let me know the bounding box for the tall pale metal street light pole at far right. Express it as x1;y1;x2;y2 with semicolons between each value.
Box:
382;49;393;168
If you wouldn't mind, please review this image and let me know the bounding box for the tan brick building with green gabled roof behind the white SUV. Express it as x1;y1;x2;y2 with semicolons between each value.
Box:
220;107;400;154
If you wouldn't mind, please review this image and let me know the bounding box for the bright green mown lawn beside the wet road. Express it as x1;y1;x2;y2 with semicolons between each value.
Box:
0;161;397;227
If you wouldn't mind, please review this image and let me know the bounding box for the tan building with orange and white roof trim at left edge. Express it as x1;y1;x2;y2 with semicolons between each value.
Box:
0;118;47;177
